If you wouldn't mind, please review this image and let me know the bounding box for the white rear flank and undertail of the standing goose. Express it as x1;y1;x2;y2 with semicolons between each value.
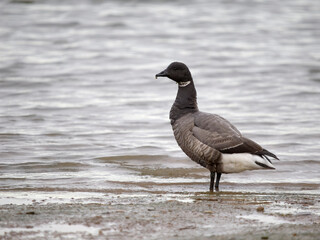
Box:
221;153;275;173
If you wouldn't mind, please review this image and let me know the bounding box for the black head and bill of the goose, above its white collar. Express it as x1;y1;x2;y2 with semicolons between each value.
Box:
156;62;192;83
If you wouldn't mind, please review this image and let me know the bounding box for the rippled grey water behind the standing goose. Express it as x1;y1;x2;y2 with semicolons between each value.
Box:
0;0;320;204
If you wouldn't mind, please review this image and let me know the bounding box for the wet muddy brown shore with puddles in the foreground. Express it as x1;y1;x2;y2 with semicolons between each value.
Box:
0;192;320;239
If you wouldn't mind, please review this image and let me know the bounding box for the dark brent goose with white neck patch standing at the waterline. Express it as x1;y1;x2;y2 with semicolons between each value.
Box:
156;62;279;192
